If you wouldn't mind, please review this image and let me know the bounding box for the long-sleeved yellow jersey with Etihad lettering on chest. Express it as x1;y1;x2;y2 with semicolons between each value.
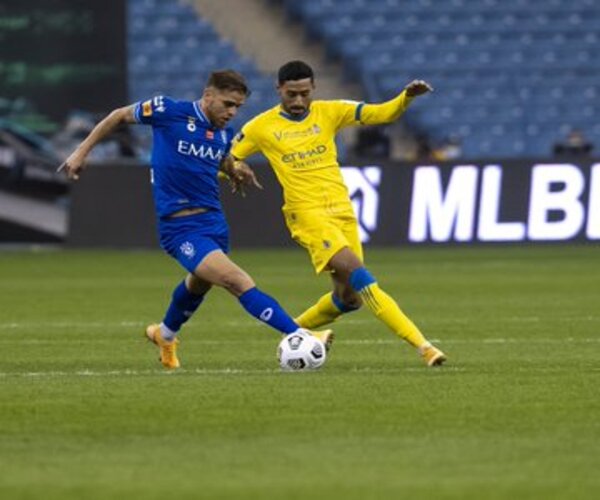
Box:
231;92;411;213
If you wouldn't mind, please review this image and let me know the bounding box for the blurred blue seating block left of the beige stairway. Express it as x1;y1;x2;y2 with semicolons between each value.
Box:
127;0;275;131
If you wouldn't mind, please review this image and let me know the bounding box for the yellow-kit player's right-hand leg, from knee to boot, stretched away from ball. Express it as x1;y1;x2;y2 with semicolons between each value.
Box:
329;247;446;366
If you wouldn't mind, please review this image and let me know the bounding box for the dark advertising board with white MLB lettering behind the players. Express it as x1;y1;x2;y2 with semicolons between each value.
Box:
68;160;600;247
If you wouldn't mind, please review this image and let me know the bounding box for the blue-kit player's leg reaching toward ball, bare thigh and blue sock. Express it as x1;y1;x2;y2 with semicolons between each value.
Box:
194;250;328;343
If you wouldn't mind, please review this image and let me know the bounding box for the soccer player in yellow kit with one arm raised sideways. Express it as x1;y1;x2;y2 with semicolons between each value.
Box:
231;61;446;366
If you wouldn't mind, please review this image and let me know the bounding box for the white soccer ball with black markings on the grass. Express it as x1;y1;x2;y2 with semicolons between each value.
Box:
277;333;327;371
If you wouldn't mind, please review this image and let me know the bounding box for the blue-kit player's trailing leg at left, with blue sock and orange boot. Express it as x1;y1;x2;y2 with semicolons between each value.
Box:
146;274;212;368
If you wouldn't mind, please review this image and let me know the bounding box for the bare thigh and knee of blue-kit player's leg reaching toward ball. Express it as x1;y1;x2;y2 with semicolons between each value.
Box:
194;250;255;297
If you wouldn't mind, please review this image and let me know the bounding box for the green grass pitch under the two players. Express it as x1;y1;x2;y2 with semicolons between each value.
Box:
0;246;600;500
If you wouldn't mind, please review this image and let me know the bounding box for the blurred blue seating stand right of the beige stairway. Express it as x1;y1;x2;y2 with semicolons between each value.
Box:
279;0;600;158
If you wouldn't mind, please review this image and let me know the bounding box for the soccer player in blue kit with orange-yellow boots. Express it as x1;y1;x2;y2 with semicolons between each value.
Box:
59;70;332;369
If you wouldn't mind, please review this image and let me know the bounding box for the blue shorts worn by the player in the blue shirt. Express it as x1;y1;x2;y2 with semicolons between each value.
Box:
158;210;229;273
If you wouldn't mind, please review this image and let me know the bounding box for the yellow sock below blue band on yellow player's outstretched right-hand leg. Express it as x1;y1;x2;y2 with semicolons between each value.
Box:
358;283;427;347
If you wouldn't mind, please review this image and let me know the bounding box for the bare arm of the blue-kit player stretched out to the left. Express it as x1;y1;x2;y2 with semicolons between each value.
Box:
57;105;136;180
